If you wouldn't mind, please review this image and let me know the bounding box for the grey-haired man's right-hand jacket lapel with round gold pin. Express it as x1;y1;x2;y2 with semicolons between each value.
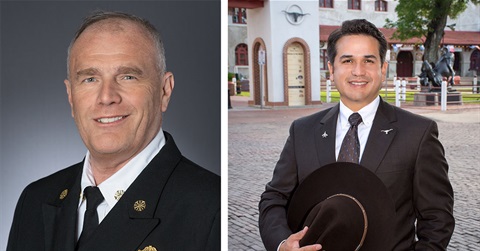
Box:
78;132;182;251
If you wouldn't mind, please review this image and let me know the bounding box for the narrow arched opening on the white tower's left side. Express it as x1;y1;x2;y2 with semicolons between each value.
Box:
252;38;268;105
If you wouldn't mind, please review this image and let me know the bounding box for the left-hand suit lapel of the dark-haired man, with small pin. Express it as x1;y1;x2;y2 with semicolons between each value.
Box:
315;105;339;167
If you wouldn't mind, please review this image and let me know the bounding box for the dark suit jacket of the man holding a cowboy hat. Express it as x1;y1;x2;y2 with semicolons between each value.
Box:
259;101;454;250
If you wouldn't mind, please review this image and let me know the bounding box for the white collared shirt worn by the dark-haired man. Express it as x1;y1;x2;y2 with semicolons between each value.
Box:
335;96;380;163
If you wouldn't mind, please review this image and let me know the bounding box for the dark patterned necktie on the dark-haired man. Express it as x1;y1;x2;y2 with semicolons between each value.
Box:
337;112;362;163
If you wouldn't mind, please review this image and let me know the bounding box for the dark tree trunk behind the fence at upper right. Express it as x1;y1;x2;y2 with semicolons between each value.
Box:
424;0;452;63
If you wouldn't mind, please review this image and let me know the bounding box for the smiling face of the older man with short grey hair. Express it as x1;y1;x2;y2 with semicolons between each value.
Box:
65;21;174;162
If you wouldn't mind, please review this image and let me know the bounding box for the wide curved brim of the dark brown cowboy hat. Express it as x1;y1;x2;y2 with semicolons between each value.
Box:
287;162;395;250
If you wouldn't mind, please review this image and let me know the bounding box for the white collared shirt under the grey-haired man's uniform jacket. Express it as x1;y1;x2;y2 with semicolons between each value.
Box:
77;128;165;240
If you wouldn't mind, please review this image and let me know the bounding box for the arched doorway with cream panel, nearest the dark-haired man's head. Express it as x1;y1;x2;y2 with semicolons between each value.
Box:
283;38;312;106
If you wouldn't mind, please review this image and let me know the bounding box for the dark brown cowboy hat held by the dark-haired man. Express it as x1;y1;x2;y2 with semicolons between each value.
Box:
287;162;395;251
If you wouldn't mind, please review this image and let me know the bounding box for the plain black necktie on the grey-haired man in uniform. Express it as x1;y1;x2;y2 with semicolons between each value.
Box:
78;186;104;246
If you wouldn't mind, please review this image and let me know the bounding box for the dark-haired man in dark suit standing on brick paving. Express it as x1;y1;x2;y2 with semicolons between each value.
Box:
259;20;454;250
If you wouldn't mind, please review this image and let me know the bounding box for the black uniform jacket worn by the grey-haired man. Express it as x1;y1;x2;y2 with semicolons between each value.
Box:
7;132;220;251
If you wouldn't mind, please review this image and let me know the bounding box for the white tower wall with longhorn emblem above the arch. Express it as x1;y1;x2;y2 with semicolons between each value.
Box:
247;0;320;102
